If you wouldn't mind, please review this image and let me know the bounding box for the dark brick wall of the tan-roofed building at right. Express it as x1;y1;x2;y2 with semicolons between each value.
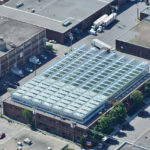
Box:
116;40;150;59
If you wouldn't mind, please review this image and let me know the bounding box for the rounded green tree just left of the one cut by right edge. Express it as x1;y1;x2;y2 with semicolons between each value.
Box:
129;90;143;107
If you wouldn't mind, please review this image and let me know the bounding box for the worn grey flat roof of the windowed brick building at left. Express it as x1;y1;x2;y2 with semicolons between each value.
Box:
0;16;45;56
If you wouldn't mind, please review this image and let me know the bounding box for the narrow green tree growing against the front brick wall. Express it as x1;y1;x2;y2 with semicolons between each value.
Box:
22;108;35;127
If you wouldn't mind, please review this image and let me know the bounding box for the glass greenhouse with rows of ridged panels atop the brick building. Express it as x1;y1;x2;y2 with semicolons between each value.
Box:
11;45;149;124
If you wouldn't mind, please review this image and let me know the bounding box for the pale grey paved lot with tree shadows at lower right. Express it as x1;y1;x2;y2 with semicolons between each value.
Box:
108;99;150;150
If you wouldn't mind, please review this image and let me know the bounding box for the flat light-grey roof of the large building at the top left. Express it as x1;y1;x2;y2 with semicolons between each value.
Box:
0;0;110;33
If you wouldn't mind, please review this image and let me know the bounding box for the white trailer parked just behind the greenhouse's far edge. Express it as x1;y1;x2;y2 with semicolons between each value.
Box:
91;39;112;49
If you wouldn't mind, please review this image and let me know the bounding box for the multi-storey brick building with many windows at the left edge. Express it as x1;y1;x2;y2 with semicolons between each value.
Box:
0;17;46;77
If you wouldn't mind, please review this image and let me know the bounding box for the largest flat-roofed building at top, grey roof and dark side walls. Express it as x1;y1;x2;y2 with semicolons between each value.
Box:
0;0;126;44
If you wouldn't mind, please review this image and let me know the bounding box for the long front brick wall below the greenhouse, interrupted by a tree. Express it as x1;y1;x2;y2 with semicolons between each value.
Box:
3;101;86;142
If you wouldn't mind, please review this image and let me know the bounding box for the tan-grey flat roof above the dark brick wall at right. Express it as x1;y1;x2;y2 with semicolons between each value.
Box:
117;19;150;49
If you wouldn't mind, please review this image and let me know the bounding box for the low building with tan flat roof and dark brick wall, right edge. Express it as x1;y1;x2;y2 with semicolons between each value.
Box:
116;17;150;59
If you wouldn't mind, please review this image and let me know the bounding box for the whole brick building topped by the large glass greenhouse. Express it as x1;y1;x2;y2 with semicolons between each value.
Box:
3;45;149;141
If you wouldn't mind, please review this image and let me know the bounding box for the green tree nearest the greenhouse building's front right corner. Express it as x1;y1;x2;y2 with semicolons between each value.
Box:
98;116;113;134
